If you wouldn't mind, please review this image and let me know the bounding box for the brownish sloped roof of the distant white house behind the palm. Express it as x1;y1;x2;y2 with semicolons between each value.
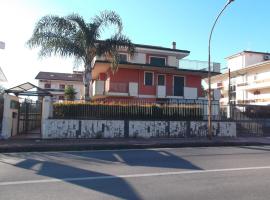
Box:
35;72;83;82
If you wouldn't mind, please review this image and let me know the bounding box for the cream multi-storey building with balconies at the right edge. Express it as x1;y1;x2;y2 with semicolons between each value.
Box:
209;51;270;105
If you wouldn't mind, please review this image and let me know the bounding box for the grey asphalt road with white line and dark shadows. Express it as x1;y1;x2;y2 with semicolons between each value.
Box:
0;146;270;200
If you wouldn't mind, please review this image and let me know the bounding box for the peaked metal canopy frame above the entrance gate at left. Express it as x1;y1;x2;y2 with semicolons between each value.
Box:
5;82;52;97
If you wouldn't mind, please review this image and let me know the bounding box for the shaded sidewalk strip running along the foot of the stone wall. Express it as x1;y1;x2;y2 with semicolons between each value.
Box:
0;137;270;153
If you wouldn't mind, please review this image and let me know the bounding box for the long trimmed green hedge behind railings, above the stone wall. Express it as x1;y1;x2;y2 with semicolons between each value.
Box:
53;103;203;120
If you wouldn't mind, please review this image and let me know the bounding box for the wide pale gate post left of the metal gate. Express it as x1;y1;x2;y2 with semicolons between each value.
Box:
0;94;19;139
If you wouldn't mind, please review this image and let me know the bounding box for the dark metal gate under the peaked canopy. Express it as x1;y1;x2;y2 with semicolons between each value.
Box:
17;99;42;134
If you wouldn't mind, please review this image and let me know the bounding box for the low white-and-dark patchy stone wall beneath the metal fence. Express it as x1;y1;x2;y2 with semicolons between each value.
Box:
42;119;236;139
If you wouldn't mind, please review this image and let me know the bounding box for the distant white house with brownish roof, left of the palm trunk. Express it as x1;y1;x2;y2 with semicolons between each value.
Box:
35;71;84;100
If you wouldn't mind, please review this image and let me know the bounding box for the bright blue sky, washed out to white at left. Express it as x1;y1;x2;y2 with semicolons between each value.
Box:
0;0;270;88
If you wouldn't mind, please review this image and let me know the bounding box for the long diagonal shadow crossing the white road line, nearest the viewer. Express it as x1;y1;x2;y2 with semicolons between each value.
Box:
15;159;141;199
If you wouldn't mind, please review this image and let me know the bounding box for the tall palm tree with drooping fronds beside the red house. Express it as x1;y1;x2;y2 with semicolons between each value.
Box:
27;11;135;100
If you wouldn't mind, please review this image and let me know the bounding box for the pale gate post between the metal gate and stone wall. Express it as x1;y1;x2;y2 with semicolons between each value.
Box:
41;96;53;138
